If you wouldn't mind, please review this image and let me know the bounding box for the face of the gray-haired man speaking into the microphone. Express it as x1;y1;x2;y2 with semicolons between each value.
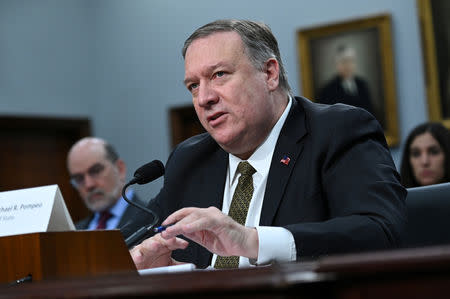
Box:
185;32;280;159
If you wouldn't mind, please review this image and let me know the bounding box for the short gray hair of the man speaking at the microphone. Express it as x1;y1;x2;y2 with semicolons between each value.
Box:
182;19;291;94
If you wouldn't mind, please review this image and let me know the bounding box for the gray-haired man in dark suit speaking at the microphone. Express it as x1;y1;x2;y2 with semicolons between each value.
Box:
131;20;406;268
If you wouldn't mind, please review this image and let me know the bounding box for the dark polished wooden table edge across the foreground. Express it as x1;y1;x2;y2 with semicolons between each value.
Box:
0;246;450;299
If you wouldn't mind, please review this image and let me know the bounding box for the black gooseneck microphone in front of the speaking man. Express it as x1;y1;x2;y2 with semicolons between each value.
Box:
122;160;164;248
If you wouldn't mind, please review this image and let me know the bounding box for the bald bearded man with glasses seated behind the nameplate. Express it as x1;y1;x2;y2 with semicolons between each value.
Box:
67;137;143;238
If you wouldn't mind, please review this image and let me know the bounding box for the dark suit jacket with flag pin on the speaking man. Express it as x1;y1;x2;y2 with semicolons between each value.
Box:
149;98;406;267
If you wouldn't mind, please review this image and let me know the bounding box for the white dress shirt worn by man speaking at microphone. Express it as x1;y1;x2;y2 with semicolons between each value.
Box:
211;98;297;267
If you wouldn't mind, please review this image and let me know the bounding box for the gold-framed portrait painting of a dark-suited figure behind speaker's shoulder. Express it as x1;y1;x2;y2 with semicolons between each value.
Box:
297;14;399;146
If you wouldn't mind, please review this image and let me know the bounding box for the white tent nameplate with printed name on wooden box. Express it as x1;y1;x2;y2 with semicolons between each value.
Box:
0;185;75;236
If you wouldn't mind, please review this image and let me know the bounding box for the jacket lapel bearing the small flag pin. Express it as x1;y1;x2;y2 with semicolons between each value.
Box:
259;98;307;226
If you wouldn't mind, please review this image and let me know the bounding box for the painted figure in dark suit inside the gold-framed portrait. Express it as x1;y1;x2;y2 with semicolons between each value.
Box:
318;45;374;115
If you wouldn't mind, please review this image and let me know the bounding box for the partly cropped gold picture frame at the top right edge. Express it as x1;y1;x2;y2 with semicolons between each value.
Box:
417;0;450;128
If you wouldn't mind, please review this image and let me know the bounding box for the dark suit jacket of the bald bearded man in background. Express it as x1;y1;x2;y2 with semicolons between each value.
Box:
75;194;146;239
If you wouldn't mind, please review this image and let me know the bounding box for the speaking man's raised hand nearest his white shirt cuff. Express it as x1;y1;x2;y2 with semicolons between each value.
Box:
161;207;259;259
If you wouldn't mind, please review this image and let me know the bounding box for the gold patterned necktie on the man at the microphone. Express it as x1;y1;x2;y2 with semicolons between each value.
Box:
214;161;256;269
